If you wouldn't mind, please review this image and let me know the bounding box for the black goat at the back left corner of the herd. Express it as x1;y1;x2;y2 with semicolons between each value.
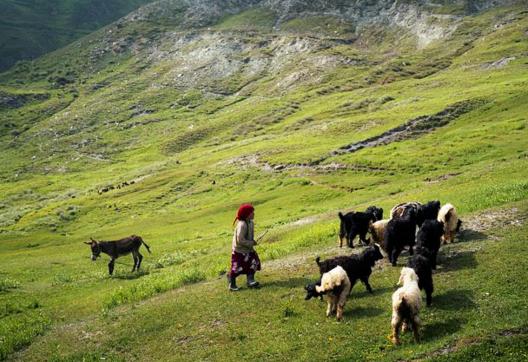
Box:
338;210;383;248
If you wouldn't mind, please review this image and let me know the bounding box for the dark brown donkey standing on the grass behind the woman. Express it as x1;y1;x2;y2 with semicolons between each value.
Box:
84;235;150;275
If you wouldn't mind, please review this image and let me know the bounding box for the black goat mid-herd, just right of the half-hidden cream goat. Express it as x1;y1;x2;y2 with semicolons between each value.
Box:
383;208;416;266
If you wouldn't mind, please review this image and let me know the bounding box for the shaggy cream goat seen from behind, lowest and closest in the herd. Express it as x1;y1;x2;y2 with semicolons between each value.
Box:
391;268;422;344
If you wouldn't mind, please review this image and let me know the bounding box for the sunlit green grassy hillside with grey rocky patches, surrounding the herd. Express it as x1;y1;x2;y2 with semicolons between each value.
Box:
0;1;528;361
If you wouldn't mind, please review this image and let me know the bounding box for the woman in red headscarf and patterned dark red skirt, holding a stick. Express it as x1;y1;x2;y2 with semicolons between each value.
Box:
228;204;260;291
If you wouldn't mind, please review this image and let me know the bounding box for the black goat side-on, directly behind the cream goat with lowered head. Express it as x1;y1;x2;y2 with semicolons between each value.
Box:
315;244;383;293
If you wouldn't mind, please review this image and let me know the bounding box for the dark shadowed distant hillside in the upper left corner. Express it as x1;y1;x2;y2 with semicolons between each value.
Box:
0;0;153;70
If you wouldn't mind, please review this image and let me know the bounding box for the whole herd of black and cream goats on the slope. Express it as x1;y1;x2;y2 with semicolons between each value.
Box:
305;201;462;344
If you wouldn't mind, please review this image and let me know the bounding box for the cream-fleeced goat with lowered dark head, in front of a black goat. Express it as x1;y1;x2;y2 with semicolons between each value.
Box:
315;265;351;321
